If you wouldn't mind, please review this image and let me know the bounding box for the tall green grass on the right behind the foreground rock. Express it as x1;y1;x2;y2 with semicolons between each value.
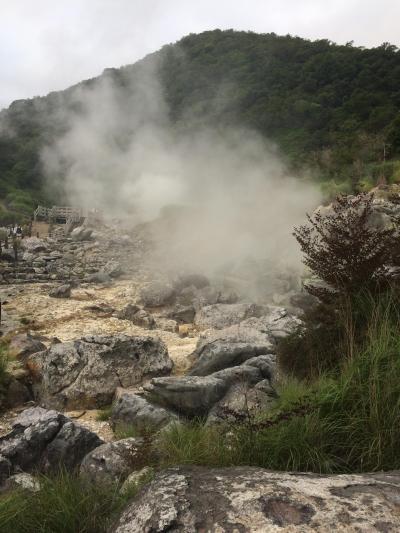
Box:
162;294;400;473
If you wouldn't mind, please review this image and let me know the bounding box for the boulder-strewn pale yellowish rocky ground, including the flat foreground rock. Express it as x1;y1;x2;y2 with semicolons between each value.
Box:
0;196;400;532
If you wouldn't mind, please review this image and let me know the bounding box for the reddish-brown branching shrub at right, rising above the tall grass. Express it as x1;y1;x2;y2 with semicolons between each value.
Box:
294;194;394;300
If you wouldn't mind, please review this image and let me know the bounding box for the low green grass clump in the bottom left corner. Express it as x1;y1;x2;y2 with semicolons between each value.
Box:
0;472;139;533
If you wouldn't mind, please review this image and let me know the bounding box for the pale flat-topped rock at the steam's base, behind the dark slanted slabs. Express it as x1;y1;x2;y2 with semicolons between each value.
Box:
194;303;267;329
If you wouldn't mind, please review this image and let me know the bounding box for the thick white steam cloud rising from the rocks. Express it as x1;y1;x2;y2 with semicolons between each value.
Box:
42;55;320;282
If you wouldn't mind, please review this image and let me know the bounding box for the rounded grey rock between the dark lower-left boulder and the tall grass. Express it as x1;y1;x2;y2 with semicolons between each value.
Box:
80;438;148;483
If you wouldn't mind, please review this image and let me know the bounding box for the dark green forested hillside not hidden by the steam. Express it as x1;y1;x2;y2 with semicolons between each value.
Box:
0;30;400;222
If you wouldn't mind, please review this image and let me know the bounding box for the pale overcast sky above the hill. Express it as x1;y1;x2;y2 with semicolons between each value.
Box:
0;0;400;108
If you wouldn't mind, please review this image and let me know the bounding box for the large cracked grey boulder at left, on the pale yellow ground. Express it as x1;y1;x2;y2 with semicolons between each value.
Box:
27;335;173;409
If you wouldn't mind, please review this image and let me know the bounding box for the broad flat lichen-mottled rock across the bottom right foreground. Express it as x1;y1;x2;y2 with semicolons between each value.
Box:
111;467;400;533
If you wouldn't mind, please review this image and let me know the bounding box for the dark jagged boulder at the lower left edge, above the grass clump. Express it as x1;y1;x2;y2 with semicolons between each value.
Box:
0;407;103;477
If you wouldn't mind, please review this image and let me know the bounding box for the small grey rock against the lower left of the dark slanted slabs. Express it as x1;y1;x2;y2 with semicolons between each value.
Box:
111;391;177;430
